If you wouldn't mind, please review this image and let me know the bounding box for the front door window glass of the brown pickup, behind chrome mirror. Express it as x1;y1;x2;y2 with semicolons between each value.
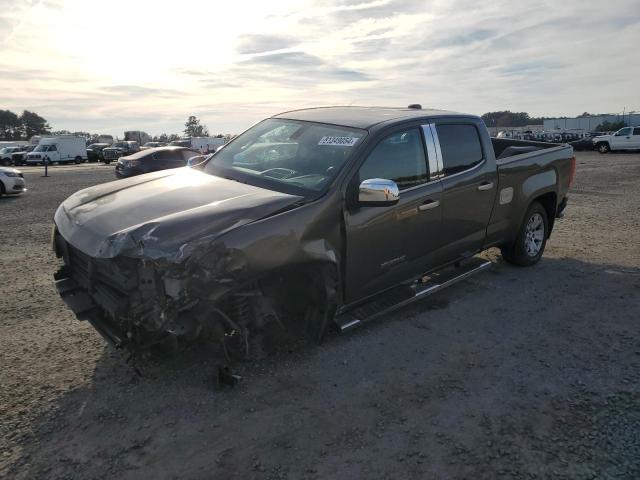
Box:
360;128;429;190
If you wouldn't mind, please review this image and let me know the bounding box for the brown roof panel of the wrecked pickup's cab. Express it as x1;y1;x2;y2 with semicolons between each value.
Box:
272;107;468;129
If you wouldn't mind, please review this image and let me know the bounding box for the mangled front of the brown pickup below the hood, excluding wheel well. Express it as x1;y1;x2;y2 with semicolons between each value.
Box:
54;229;268;353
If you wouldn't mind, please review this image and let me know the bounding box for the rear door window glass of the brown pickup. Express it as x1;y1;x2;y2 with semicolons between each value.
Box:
436;124;482;175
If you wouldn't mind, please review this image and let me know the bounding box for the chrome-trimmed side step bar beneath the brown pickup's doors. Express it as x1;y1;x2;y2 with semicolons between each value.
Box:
335;258;492;332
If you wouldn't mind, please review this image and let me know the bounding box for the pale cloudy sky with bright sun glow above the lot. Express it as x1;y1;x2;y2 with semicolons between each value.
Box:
0;0;640;136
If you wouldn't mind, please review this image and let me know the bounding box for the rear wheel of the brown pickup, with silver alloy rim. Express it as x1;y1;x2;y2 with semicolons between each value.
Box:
502;202;549;267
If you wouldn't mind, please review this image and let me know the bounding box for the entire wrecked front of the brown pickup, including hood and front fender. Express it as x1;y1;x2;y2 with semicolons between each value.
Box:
53;170;339;357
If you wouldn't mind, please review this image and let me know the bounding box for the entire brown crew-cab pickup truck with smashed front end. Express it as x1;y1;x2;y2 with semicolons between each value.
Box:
53;105;575;353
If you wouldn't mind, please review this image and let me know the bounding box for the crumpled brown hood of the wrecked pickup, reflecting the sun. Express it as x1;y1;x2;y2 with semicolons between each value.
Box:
55;168;302;262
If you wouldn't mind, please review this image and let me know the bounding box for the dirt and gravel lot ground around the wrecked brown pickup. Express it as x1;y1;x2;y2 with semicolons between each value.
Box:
0;153;640;479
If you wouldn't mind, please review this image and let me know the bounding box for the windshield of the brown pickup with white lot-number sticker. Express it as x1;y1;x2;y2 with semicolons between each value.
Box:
204;118;366;192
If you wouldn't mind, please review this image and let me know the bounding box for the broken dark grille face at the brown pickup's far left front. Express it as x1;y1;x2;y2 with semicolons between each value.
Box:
54;231;137;347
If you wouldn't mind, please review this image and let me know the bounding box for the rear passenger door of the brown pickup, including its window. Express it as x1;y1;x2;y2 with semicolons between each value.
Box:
435;119;498;262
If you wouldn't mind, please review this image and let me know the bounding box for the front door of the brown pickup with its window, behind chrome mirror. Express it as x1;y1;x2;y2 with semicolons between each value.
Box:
345;127;442;303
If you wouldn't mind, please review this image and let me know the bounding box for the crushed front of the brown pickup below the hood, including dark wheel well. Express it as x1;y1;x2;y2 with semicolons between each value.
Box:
53;225;335;359
